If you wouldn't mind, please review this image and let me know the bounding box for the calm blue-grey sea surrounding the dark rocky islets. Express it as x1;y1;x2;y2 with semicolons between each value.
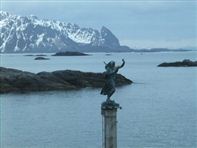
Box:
0;52;197;148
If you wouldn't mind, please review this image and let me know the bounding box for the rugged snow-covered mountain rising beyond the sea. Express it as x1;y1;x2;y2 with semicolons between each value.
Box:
0;11;129;53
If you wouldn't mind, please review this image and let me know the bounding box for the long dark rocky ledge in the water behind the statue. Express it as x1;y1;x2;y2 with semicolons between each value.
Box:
0;67;132;93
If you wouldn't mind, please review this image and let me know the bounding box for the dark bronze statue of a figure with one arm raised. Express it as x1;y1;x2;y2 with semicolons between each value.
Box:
101;59;125;101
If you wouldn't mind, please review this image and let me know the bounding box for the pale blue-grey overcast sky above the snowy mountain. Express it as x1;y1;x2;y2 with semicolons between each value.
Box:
0;0;197;48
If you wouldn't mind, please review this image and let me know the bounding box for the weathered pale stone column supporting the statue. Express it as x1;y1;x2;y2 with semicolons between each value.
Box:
101;101;120;148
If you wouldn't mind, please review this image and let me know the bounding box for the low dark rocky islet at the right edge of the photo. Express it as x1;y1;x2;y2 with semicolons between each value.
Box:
158;59;197;67
